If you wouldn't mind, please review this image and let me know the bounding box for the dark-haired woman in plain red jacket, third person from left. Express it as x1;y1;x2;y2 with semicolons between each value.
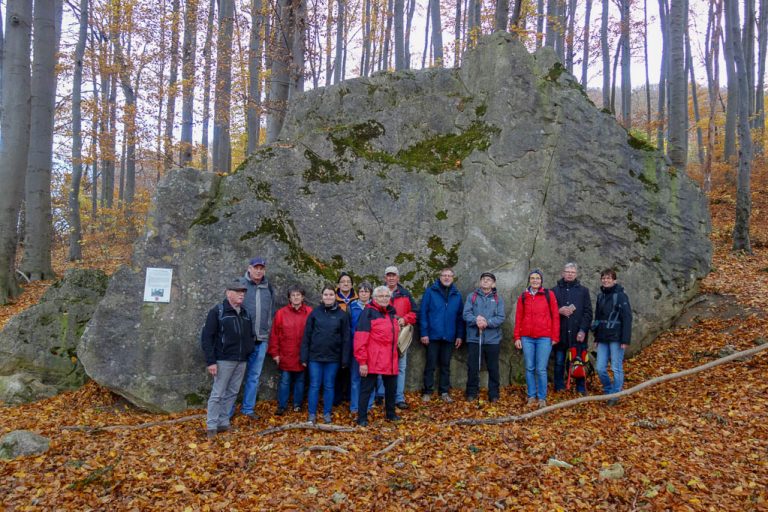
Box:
267;285;312;416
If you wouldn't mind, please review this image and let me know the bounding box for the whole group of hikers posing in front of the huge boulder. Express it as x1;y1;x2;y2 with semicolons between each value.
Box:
201;257;632;438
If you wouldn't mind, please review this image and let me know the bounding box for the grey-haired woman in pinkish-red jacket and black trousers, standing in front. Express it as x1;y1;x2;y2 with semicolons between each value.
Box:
355;286;400;427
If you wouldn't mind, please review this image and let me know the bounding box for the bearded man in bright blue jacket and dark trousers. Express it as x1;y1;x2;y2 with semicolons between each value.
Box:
419;268;464;403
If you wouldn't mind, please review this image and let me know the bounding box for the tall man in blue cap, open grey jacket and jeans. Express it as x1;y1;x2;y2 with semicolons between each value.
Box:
240;257;275;419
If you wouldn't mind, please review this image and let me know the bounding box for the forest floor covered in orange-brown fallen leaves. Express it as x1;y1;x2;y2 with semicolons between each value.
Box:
0;168;768;511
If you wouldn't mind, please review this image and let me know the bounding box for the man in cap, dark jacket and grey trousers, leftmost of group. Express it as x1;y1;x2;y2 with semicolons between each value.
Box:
200;279;254;439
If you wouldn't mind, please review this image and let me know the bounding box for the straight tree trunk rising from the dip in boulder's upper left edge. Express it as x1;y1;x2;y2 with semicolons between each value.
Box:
213;0;234;173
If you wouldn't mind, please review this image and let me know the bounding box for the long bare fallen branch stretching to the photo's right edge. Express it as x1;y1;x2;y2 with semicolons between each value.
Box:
449;343;768;425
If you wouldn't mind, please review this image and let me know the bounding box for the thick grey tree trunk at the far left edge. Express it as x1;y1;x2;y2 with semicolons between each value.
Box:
0;0;32;304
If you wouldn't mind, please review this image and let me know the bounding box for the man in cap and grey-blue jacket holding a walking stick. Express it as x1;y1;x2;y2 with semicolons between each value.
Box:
463;272;504;402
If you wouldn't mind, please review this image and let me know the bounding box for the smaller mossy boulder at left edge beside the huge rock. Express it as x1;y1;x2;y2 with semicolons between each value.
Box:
0;269;107;403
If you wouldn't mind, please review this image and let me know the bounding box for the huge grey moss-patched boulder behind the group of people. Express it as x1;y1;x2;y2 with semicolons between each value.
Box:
78;34;711;411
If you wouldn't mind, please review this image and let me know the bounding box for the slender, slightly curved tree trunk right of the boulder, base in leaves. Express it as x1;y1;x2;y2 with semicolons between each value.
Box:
724;0;752;254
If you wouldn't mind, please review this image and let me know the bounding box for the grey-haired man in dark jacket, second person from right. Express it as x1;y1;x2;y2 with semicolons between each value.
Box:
552;263;592;395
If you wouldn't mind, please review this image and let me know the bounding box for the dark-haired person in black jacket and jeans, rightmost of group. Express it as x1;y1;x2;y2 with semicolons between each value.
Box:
592;268;632;405
